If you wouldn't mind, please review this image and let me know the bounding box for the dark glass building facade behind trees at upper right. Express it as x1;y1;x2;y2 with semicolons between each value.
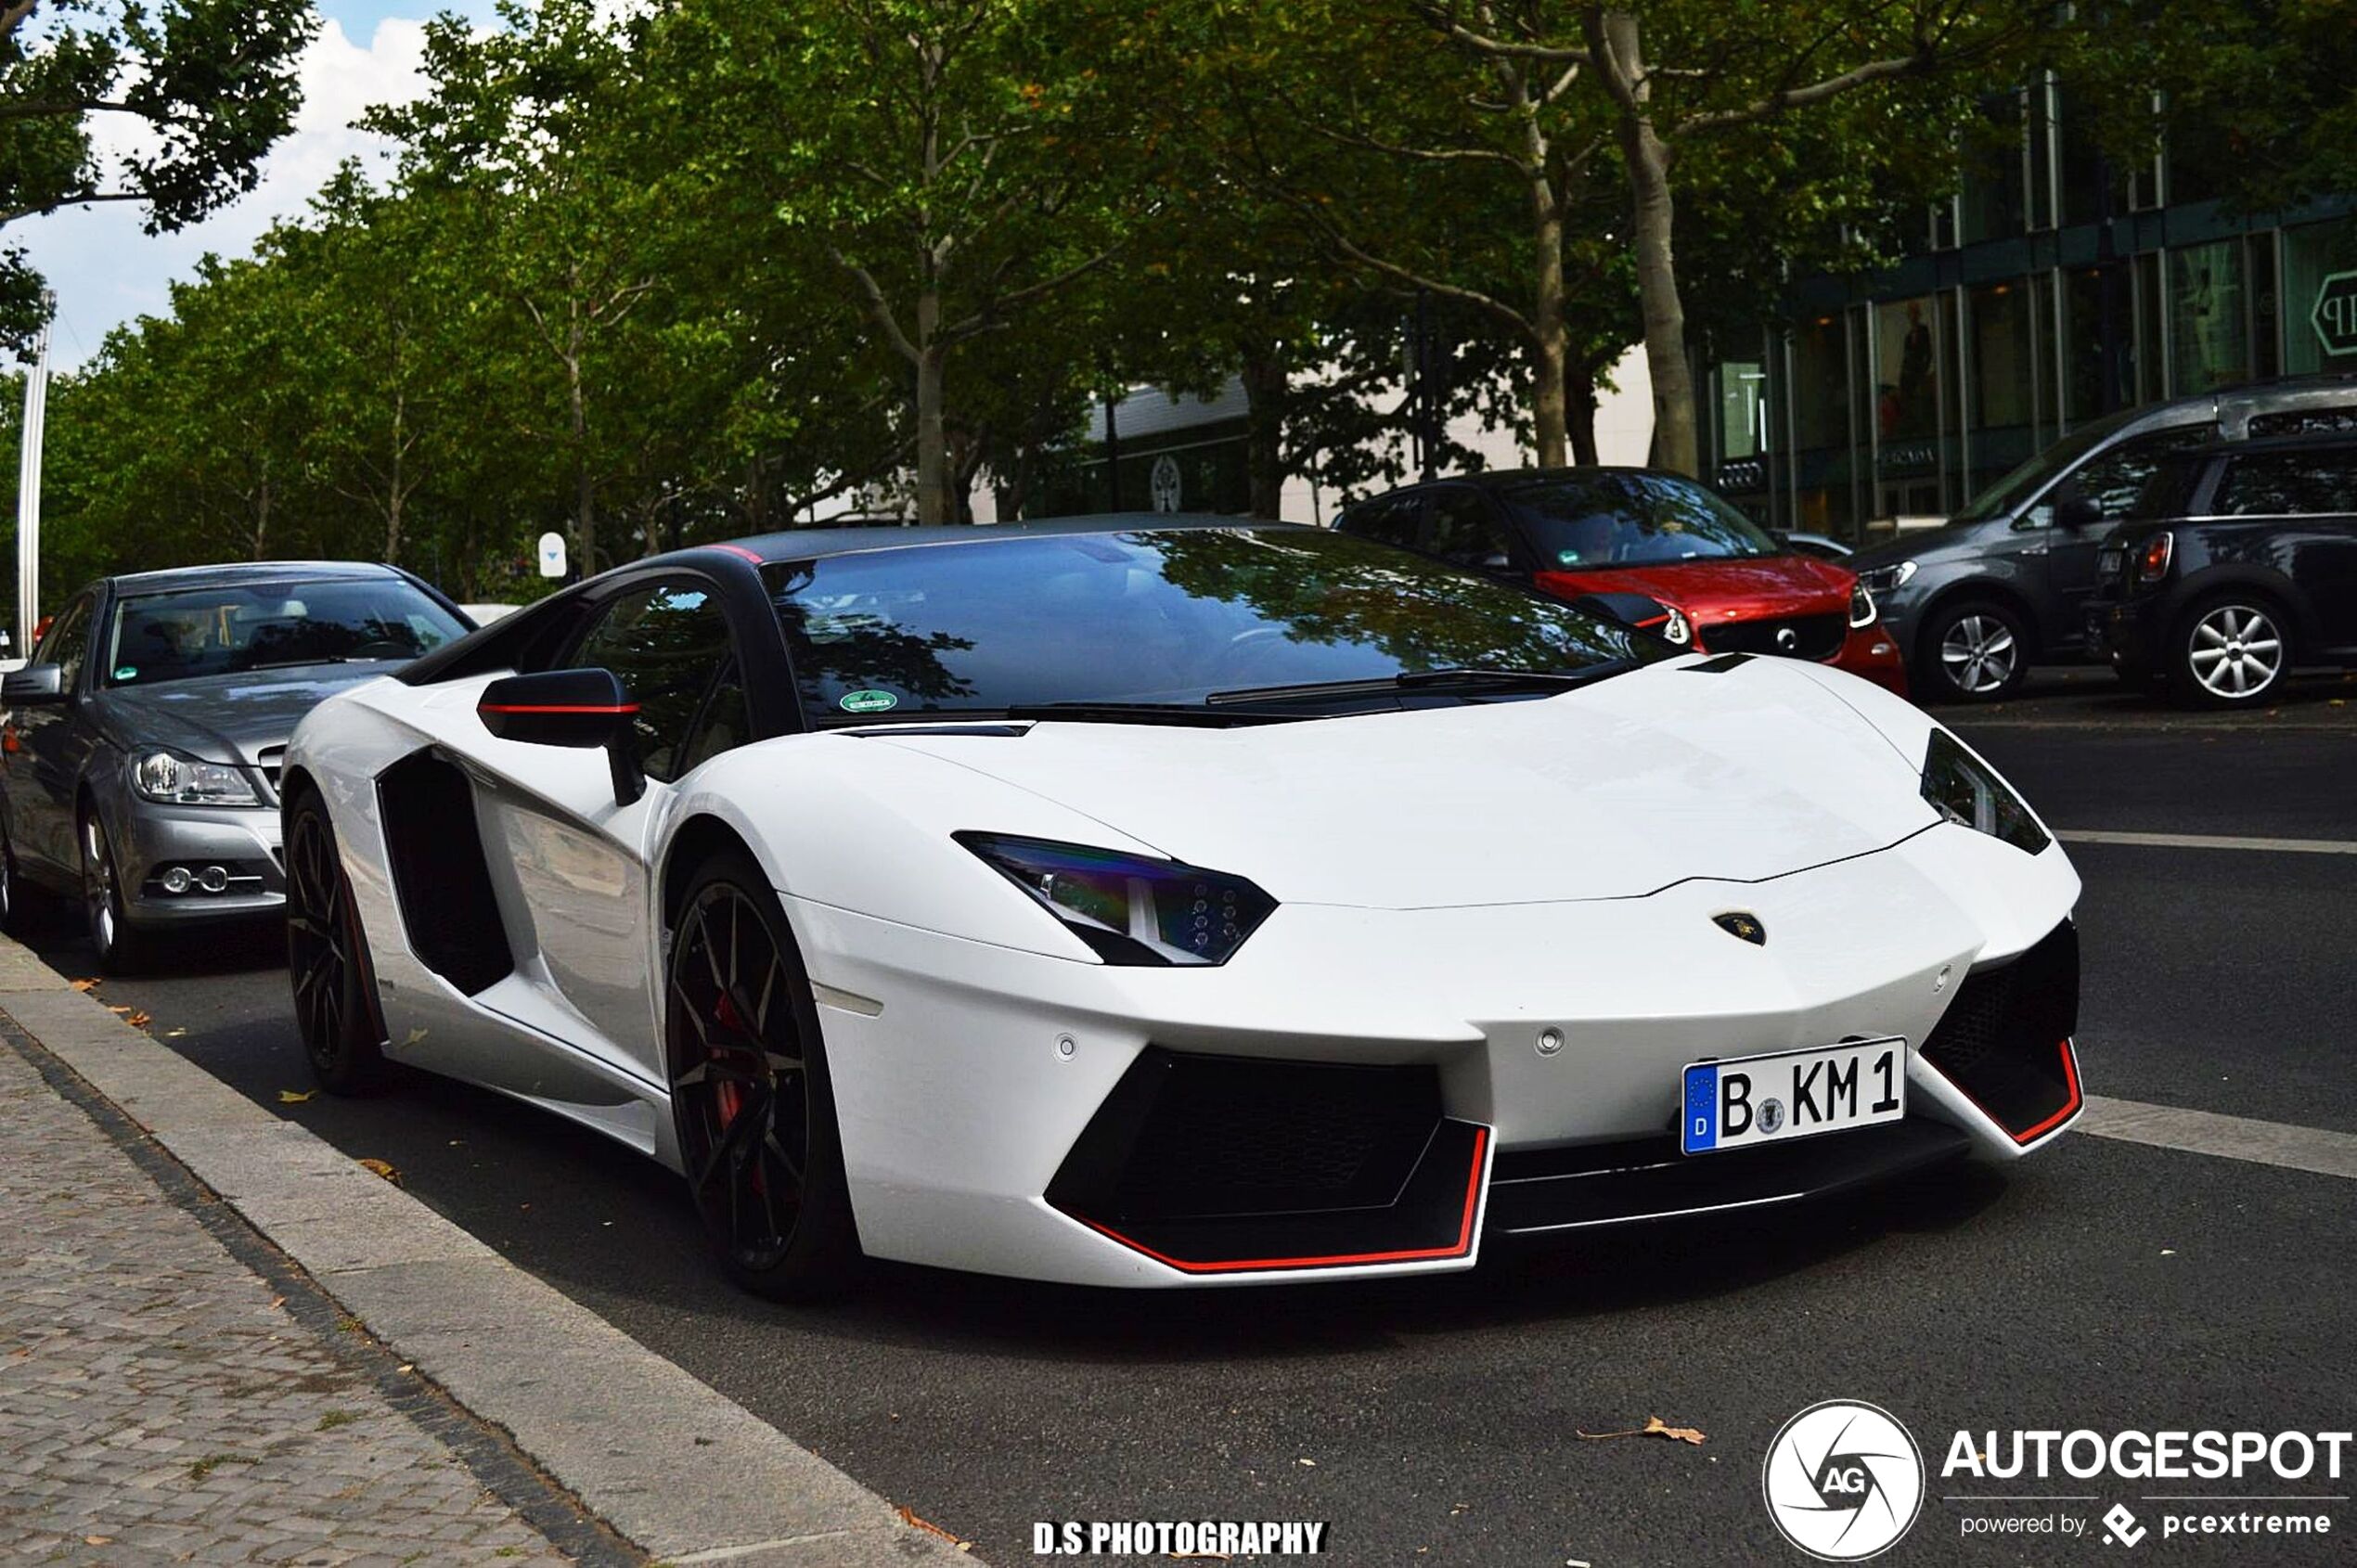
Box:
1702;83;2357;540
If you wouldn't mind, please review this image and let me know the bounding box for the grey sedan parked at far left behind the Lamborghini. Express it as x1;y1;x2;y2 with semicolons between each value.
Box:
0;549;471;971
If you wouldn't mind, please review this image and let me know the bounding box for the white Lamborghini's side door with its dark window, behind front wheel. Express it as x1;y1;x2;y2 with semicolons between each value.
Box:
466;573;750;1082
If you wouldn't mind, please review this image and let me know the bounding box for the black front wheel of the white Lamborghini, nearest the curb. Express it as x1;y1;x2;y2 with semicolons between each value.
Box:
663;849;860;1302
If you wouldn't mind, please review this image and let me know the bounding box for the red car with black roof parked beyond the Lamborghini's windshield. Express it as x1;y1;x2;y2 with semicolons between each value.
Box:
1334;467;1907;696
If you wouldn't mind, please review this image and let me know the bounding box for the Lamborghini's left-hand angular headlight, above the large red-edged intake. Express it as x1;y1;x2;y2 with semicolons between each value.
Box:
952;832;1278;964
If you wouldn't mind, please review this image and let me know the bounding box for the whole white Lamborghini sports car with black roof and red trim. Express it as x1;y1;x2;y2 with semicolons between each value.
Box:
283;517;2079;1292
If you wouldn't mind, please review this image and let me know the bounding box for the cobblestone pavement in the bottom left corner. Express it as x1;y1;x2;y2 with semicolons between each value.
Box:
0;1042;568;1568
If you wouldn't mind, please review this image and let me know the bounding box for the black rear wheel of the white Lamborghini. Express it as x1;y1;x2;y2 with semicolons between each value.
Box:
285;790;387;1094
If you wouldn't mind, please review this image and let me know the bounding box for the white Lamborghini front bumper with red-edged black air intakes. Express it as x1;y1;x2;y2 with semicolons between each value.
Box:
787;825;2079;1285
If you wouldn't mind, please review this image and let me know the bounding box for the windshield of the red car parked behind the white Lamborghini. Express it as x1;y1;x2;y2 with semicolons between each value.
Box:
1499;471;1786;571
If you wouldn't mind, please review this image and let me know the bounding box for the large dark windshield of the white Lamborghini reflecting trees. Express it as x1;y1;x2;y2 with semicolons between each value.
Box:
764;528;1673;724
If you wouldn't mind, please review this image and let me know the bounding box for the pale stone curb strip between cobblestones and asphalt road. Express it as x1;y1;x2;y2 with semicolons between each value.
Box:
0;936;976;1568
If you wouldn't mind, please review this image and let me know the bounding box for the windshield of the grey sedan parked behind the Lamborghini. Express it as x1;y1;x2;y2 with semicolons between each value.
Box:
106;578;464;687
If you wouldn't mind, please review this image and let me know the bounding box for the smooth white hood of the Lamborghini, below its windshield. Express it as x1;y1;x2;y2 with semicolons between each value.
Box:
889;661;1935;907
